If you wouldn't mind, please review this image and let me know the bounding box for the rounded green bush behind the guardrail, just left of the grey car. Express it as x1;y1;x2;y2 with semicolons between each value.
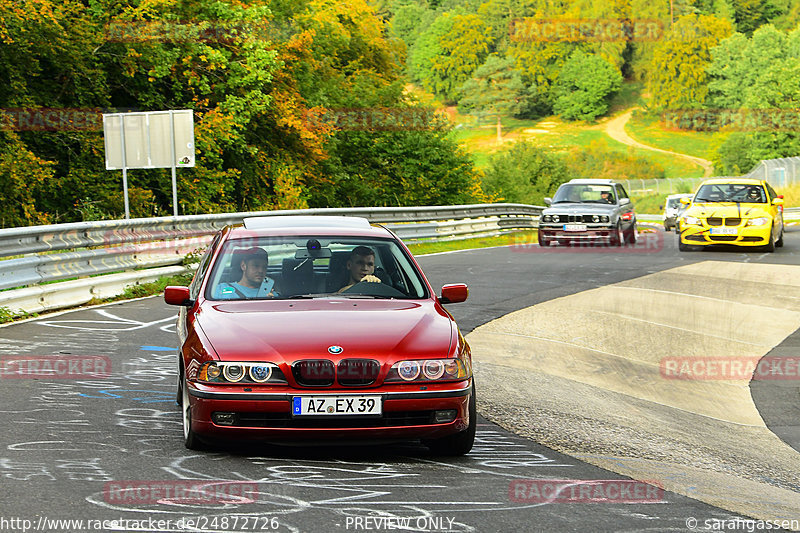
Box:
483;142;570;205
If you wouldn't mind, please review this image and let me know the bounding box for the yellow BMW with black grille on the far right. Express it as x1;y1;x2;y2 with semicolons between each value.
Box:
678;178;783;252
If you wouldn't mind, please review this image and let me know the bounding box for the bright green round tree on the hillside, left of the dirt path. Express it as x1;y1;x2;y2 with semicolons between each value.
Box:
552;50;622;120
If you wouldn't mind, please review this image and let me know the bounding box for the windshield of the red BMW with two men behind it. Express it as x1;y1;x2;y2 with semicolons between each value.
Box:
205;236;428;300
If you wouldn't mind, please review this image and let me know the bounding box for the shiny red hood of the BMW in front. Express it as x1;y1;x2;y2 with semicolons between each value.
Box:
197;298;457;363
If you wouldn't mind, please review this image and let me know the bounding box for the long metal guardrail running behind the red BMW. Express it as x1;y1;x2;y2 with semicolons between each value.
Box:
0;203;544;307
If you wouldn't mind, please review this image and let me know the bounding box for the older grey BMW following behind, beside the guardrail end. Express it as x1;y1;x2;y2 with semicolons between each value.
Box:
539;179;636;246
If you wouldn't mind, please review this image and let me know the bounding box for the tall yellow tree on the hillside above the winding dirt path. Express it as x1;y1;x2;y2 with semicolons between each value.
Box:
648;15;732;109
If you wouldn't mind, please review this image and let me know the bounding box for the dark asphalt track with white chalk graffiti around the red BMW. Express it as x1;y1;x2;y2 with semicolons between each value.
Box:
0;225;800;532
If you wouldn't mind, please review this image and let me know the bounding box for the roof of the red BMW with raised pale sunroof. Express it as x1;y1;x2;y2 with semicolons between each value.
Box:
228;215;393;239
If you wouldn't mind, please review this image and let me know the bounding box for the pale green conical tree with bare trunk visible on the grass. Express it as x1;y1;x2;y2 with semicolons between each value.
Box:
458;56;525;144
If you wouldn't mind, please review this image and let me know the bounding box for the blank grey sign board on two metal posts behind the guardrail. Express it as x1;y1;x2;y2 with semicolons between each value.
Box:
103;109;195;219
